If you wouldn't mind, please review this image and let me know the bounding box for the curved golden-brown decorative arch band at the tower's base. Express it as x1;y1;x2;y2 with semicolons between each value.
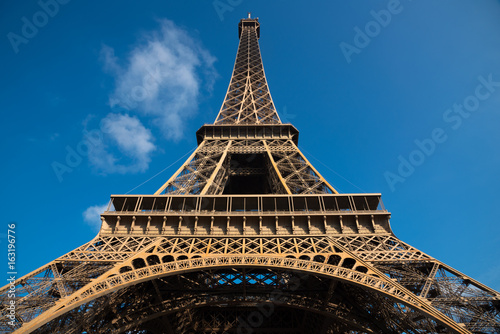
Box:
19;254;467;333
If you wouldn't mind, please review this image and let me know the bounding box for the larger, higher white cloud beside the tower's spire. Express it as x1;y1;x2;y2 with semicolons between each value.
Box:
102;20;216;140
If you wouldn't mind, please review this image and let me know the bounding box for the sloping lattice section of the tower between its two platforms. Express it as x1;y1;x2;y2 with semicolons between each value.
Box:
156;139;337;195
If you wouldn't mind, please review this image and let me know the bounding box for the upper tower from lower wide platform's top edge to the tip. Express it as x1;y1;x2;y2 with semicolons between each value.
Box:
155;18;337;195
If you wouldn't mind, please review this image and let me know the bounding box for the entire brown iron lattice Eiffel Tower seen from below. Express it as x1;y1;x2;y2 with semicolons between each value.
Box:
0;16;500;334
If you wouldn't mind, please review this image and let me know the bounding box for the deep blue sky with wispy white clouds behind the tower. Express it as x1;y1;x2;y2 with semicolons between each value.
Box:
0;0;500;290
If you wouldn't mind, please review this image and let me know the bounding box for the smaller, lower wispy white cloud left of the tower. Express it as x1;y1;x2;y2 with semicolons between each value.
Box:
86;113;156;174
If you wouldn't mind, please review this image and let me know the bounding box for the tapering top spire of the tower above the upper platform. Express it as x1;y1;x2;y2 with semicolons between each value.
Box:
215;13;281;124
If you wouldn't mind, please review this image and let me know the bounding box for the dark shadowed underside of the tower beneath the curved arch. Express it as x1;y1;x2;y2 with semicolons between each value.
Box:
30;267;442;334
